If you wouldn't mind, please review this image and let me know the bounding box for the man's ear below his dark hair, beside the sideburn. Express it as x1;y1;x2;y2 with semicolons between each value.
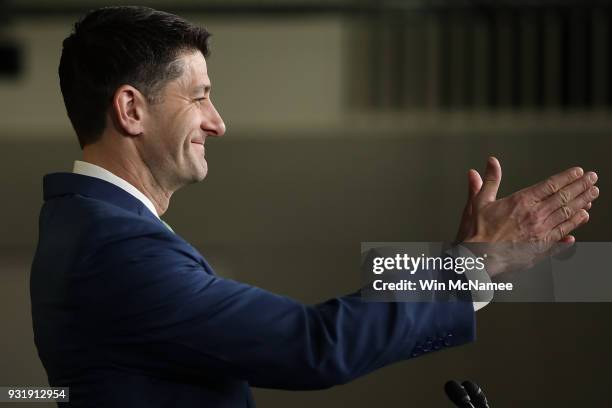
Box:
110;85;147;136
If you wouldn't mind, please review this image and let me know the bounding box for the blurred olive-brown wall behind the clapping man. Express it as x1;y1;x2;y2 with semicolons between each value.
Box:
0;0;612;407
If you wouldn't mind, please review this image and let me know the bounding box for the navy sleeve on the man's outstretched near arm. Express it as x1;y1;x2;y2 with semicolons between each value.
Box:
76;228;475;390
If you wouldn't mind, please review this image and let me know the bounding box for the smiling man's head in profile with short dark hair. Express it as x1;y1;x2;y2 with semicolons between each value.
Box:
59;7;225;187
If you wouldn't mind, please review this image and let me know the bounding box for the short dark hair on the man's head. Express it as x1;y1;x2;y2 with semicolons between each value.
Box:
59;6;210;148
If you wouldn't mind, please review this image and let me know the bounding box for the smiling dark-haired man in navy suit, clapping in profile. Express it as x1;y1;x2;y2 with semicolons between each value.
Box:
31;7;597;407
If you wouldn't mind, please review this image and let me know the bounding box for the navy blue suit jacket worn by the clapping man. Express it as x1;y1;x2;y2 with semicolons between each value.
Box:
30;173;474;408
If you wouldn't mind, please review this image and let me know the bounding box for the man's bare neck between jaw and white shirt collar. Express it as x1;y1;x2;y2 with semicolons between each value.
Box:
83;138;174;217
